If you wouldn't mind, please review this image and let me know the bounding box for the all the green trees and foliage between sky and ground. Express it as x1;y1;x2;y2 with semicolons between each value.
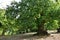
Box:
0;0;60;35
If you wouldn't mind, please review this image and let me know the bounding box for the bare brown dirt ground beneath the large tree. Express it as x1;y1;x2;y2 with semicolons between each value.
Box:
0;31;60;40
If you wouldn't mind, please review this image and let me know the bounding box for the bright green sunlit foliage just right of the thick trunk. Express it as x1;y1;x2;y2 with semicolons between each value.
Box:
45;20;59;30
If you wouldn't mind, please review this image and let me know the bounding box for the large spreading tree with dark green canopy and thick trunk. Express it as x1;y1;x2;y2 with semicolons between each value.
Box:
5;0;60;35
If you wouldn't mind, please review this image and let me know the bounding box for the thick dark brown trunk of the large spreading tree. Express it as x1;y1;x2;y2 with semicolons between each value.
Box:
37;19;49;35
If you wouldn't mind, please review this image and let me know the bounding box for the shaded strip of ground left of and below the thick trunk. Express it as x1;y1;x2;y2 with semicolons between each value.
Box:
0;33;48;40
